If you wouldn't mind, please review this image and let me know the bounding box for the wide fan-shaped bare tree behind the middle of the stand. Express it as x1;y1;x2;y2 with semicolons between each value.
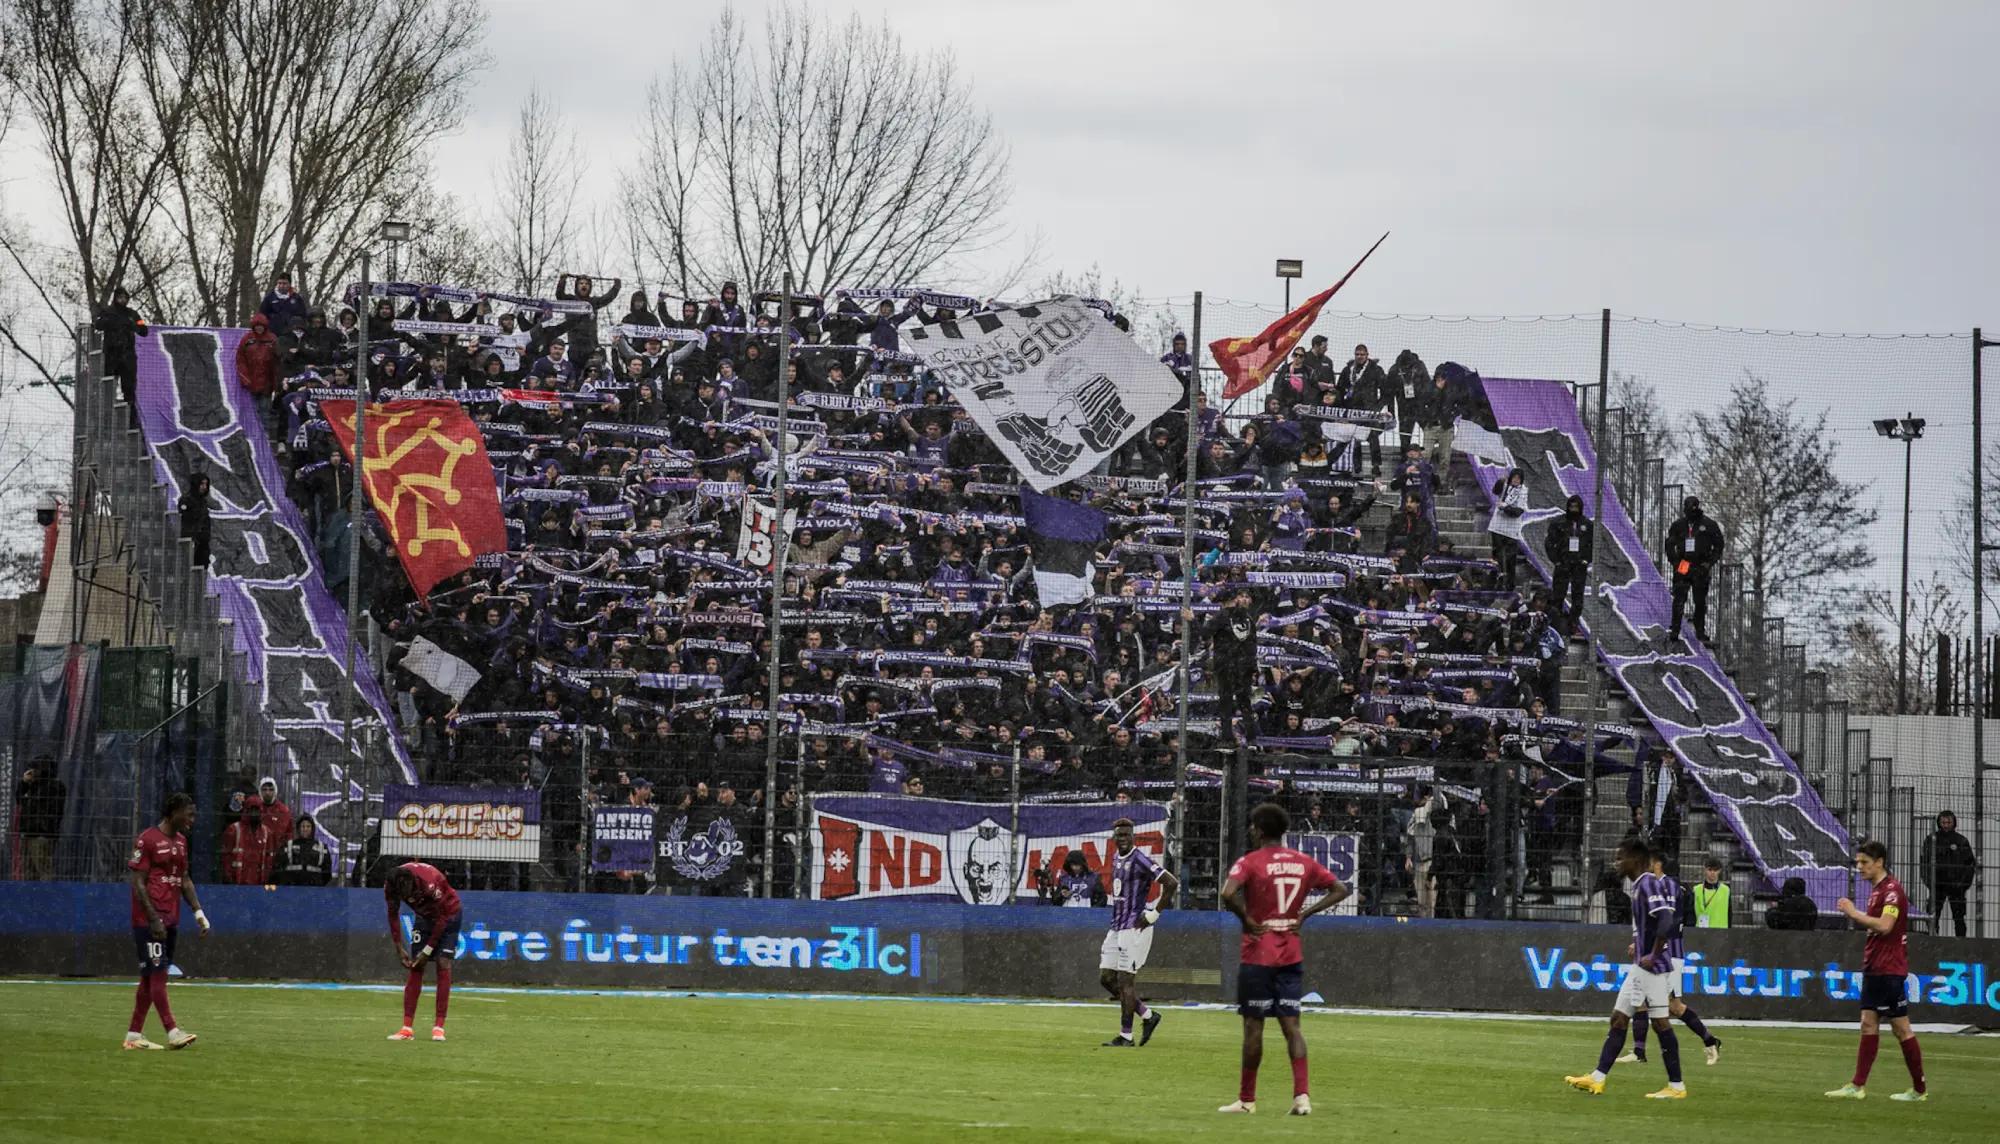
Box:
620;4;1010;296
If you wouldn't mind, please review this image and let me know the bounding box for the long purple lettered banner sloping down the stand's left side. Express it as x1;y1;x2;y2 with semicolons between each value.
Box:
138;328;416;844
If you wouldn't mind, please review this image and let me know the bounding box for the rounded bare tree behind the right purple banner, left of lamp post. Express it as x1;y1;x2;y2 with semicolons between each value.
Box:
1686;372;1876;638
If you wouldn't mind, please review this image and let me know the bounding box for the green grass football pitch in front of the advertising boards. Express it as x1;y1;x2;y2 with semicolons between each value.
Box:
0;982;2000;1144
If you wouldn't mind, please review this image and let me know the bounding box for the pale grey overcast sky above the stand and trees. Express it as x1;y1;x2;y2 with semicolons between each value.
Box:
442;0;2000;332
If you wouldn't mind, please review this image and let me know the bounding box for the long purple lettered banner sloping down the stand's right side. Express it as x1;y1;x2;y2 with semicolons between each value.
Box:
1468;378;1850;908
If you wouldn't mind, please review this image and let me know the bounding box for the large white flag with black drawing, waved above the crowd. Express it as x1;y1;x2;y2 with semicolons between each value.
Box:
906;296;1182;492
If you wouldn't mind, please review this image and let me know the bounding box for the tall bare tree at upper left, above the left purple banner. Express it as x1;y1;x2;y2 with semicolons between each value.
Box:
128;0;484;324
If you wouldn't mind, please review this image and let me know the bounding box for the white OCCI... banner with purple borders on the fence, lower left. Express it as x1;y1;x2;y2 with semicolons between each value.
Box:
382;784;542;862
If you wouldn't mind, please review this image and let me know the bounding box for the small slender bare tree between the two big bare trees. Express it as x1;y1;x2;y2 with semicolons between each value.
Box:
494;84;588;294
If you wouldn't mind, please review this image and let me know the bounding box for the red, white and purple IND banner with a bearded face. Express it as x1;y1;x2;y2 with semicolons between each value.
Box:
812;794;1166;906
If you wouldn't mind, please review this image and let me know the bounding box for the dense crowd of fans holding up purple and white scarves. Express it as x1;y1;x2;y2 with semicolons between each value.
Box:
145;274;1672;912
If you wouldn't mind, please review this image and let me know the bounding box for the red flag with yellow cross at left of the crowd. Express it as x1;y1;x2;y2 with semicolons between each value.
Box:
320;400;506;596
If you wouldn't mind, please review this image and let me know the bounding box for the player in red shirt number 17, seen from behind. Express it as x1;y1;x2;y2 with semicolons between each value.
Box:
1216;802;1350;1116
